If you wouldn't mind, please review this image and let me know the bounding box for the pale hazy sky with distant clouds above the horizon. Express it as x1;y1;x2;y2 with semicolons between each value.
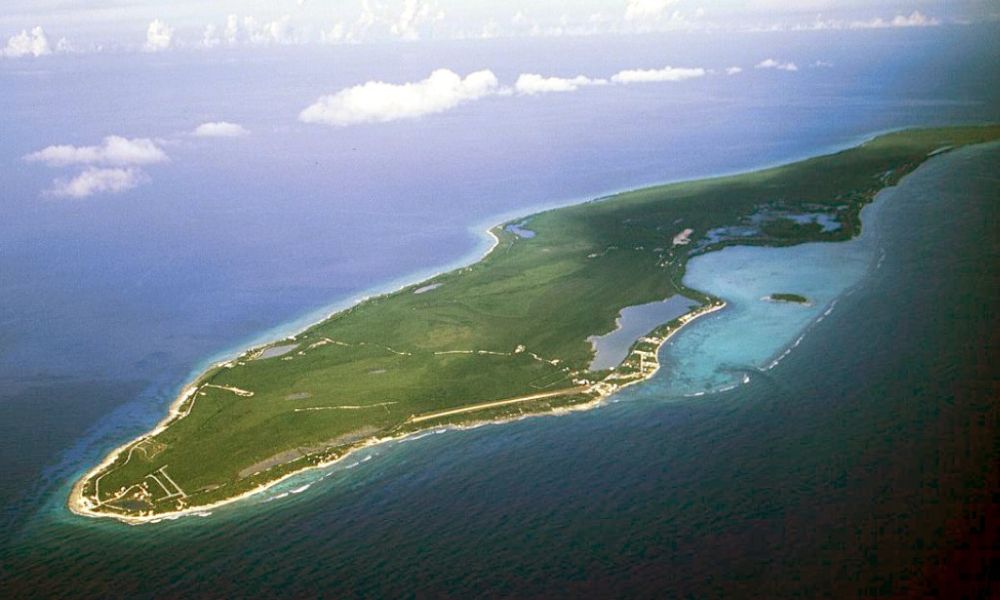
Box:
0;0;1000;58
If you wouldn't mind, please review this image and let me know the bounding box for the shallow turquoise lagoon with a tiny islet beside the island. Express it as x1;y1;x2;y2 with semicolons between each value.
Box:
663;189;898;396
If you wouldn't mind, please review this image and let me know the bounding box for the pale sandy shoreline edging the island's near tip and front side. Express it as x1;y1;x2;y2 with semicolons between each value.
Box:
67;298;727;525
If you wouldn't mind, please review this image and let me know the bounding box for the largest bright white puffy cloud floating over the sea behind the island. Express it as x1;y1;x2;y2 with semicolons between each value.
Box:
299;69;499;126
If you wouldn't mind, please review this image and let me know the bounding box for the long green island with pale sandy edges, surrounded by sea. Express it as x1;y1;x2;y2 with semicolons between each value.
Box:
69;125;1000;523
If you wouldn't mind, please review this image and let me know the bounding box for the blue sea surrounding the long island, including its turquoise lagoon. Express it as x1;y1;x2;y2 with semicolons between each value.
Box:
0;26;1000;598
